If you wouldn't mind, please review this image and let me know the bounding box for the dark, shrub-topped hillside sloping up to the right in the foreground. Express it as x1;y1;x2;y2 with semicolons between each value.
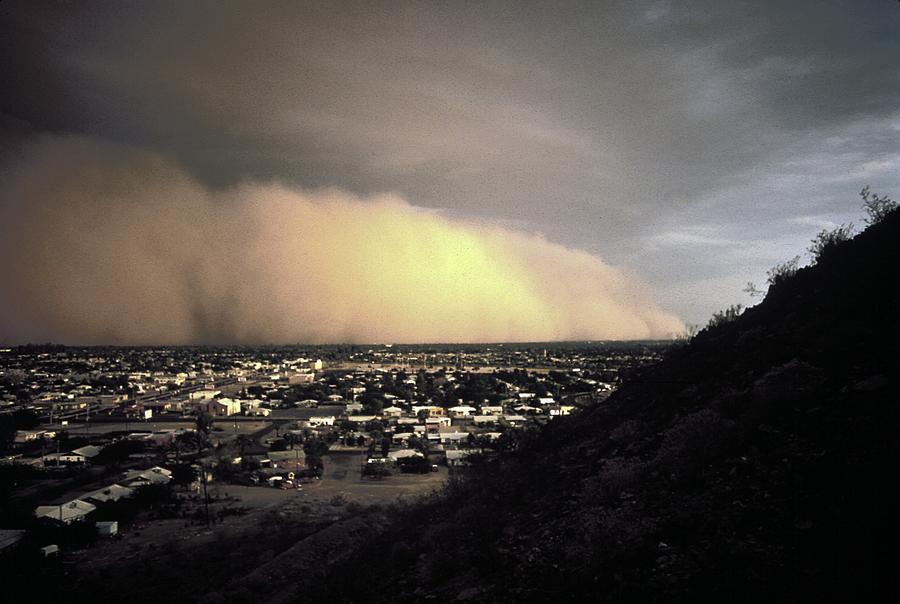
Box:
314;211;900;602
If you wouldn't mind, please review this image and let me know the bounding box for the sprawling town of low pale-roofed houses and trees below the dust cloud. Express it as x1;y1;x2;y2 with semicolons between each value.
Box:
0;342;664;565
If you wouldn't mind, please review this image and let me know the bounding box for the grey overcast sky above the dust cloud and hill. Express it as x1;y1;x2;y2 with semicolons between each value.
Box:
0;0;900;336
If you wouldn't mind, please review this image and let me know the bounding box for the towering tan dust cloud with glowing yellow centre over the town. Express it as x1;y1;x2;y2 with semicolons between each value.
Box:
0;137;683;344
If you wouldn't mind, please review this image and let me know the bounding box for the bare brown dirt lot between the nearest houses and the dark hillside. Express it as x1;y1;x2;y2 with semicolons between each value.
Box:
66;452;447;588
